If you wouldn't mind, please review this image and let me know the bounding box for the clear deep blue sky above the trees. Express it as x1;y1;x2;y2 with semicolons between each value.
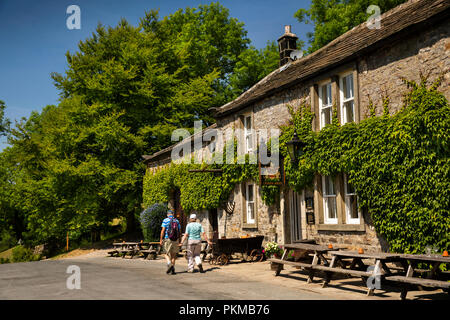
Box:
0;0;312;150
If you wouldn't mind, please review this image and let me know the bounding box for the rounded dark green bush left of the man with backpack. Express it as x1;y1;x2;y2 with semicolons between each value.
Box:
140;203;168;241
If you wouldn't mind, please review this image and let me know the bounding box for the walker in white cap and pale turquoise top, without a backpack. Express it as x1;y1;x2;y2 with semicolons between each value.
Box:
179;214;212;273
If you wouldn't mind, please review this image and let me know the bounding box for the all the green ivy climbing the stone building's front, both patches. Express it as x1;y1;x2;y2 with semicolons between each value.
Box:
144;76;450;253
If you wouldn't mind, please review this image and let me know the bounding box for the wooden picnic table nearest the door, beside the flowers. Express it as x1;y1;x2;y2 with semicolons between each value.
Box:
269;243;336;283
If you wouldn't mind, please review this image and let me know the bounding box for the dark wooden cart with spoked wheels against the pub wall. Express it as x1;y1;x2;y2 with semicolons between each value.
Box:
206;236;264;265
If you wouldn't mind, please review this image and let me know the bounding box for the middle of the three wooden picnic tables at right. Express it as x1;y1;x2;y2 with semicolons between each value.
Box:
322;250;400;296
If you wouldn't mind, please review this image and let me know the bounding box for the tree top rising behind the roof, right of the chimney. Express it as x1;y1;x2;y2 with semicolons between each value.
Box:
294;0;406;52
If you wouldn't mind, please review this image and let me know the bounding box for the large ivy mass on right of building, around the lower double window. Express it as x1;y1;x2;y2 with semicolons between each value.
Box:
280;77;450;253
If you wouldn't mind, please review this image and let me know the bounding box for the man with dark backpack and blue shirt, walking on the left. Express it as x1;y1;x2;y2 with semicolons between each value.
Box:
159;210;181;274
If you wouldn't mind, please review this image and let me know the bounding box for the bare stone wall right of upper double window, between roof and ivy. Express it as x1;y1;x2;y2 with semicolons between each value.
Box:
357;20;450;119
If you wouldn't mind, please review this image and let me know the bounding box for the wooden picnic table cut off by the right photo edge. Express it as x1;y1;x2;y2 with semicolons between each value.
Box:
385;254;450;300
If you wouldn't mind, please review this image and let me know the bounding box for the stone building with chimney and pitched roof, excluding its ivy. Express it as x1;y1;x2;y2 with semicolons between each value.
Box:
144;0;450;251
